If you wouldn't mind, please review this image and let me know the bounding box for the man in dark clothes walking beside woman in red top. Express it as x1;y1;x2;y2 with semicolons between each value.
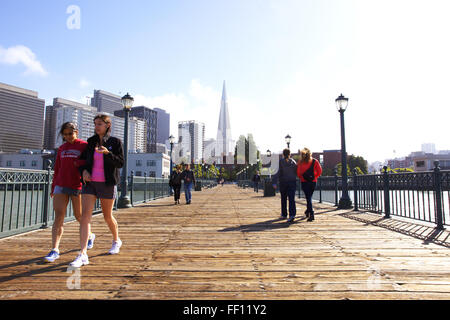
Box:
273;149;297;223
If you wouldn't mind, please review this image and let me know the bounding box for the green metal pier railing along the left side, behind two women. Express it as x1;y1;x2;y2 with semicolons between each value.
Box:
0;166;217;238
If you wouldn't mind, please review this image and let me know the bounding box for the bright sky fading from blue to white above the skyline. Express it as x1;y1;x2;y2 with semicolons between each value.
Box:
0;0;450;162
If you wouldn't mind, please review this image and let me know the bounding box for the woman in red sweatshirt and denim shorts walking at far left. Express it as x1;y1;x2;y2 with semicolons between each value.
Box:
44;122;95;262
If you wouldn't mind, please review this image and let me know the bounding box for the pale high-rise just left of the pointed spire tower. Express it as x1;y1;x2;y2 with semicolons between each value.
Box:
177;120;205;163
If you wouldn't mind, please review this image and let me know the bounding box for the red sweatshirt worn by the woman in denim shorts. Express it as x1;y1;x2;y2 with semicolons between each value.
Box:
52;139;87;193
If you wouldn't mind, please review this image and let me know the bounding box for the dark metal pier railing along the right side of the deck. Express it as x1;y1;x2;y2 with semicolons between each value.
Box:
237;161;450;229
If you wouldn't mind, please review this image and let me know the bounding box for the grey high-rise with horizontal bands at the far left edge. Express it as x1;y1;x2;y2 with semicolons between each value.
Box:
0;83;45;152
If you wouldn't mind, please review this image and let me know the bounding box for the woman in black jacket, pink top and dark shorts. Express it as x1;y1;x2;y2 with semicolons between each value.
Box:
70;114;124;268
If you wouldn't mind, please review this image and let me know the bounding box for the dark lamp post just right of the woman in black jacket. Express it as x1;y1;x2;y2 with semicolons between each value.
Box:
117;93;134;208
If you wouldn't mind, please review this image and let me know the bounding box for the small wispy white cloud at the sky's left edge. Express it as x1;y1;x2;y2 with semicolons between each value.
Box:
0;45;48;76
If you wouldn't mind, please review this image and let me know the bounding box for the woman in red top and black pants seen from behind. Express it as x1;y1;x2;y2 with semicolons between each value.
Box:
297;148;322;221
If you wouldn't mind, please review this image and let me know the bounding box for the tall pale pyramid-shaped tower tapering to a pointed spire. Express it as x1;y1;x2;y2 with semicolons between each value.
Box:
216;80;234;159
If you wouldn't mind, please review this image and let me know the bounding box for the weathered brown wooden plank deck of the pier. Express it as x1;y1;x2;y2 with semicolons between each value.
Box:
0;185;450;300
